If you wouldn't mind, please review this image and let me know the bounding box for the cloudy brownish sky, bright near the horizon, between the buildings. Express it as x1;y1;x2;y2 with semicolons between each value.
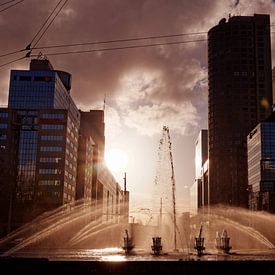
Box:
0;0;275;222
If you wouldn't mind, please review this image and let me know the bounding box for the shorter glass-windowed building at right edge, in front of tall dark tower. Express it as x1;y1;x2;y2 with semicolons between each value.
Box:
247;113;275;213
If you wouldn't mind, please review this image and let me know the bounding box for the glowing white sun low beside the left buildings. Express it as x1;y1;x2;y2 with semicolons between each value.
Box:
105;148;128;173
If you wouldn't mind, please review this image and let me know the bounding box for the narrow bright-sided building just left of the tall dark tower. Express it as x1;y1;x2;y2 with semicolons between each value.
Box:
190;130;209;212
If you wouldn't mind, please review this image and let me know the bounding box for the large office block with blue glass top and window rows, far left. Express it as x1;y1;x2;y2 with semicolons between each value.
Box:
0;59;80;234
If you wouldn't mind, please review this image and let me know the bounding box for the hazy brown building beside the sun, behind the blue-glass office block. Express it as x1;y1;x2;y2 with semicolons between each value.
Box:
77;110;123;224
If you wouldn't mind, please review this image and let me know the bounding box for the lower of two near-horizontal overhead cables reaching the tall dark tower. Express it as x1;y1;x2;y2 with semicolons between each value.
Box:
30;39;207;57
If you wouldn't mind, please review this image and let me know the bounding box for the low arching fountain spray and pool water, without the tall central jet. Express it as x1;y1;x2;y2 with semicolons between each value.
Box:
0;204;275;261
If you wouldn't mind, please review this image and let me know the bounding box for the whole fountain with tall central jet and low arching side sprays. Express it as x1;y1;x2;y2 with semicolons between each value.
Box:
0;127;275;260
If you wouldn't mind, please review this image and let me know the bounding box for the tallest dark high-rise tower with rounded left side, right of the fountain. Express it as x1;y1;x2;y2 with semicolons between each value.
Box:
208;14;272;207
